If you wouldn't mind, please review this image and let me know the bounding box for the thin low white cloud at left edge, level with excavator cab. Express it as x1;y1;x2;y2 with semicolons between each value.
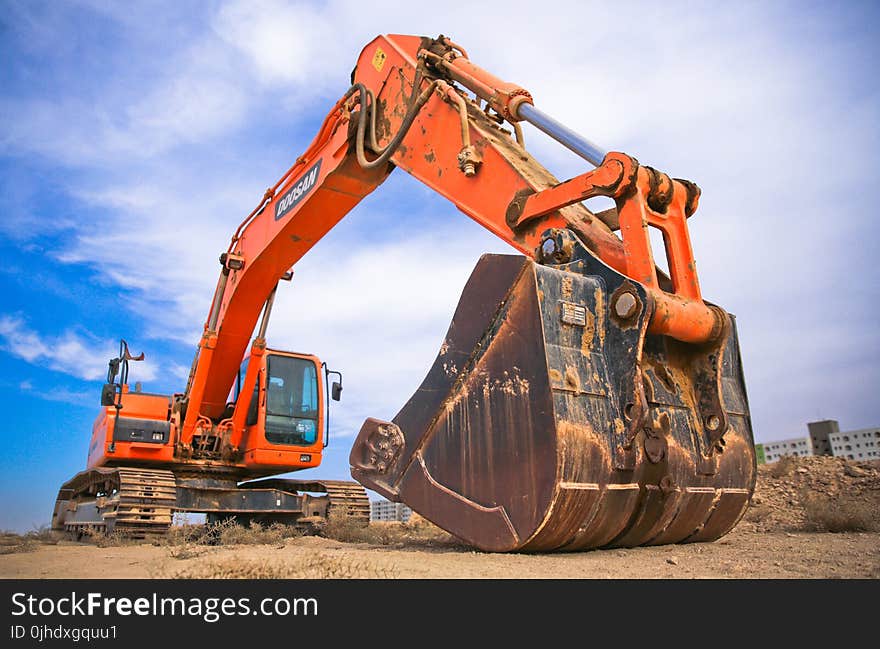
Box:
0;315;156;381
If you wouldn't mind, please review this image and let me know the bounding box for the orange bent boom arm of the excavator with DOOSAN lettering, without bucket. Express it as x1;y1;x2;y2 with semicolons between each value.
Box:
180;35;723;444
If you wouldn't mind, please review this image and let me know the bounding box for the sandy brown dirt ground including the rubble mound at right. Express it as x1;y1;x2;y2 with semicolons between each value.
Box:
0;458;880;579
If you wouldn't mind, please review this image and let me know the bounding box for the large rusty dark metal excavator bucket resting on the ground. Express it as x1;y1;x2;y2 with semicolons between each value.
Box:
350;242;756;552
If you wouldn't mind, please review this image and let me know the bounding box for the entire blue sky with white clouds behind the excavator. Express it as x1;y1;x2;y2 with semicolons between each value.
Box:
0;0;880;530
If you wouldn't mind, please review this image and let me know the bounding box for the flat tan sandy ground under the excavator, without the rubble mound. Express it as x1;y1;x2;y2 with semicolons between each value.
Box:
0;523;880;579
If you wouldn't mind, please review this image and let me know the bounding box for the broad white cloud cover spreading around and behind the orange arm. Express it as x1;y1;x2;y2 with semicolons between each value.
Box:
0;0;880;450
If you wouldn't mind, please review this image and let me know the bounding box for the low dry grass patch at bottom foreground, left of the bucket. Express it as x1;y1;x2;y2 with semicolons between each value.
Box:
156;552;396;579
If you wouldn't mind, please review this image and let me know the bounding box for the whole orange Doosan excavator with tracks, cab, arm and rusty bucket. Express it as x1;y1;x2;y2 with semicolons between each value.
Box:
53;35;756;552
